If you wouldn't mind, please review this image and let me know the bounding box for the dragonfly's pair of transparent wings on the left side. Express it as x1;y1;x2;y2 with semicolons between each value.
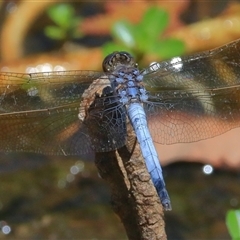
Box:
0;71;128;157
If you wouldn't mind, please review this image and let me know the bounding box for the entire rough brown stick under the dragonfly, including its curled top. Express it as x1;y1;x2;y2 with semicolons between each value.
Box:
79;56;166;240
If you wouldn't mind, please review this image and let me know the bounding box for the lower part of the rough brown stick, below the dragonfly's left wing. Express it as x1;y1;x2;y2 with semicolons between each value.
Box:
95;144;167;240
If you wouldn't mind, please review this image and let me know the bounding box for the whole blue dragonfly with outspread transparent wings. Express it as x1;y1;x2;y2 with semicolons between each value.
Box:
0;40;240;210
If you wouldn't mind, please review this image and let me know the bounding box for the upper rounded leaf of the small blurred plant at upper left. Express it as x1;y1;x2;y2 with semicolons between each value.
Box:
48;4;74;28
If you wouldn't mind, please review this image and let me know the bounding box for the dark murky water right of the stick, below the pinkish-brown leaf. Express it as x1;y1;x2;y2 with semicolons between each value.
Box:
164;163;240;240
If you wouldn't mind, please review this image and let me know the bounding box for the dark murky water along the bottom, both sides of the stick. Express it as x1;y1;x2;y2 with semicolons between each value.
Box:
0;154;240;239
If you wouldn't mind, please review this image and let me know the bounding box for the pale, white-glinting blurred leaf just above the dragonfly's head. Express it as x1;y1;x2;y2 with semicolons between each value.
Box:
112;21;136;48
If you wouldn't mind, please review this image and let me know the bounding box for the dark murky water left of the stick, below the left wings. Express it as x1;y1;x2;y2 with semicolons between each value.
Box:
0;154;126;239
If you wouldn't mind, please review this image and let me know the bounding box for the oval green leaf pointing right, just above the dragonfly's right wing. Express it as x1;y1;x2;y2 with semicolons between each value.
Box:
149;38;185;59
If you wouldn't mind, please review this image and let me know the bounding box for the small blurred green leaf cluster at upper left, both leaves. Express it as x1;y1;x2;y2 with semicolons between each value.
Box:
44;4;83;41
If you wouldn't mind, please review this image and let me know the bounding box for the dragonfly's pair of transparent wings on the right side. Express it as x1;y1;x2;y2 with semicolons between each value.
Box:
144;40;240;144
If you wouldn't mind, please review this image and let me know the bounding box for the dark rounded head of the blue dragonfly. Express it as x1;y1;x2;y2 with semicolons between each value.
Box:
102;51;137;73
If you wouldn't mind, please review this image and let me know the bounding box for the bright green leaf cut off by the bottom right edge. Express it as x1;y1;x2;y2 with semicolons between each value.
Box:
226;210;240;239
